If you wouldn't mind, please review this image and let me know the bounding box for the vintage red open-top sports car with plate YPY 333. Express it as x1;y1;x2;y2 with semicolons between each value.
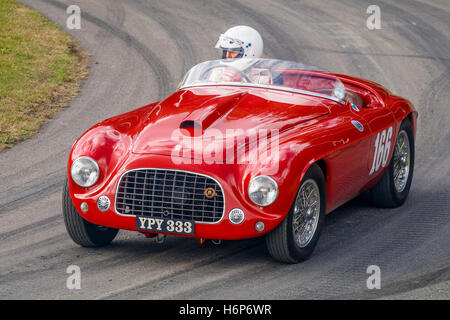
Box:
63;59;417;263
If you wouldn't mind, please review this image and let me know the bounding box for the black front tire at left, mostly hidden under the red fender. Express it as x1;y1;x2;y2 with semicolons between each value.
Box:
62;180;119;248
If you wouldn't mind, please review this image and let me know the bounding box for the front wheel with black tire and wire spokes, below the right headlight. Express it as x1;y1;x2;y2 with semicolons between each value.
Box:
266;164;326;263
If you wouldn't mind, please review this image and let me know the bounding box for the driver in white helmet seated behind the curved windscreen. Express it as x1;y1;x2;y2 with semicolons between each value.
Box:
209;26;272;84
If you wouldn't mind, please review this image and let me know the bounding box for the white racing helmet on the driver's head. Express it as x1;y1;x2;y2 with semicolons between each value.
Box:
215;26;264;59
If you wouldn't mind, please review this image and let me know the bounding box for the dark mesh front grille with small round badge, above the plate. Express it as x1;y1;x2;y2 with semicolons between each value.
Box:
116;169;224;223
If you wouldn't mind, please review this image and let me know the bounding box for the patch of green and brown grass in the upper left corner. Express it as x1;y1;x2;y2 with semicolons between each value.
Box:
0;0;87;151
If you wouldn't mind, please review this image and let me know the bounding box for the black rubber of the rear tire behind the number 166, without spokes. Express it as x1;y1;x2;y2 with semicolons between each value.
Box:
369;118;415;208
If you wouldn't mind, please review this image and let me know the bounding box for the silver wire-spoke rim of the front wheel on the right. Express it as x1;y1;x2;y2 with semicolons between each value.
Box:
292;179;320;248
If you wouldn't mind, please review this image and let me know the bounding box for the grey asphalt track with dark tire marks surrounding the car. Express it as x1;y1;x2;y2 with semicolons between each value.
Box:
0;0;450;299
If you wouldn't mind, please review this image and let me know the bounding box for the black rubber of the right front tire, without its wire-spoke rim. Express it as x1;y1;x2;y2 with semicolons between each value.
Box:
266;164;326;263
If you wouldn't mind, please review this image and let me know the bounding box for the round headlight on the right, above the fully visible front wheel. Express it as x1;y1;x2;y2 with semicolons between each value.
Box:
248;176;278;207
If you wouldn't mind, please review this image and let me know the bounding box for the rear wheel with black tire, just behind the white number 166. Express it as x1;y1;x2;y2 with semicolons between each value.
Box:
370;118;415;208
